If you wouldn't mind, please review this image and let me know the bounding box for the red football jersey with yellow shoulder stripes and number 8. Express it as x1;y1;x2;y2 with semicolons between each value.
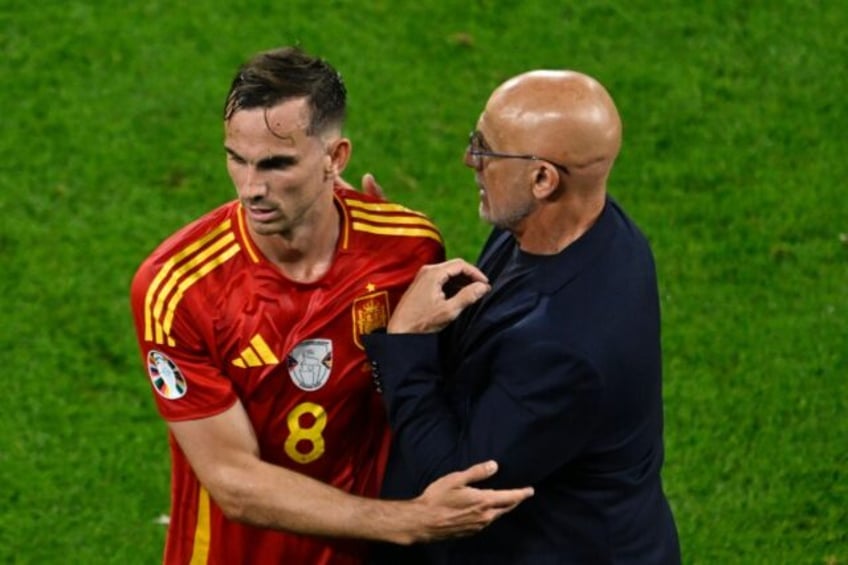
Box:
132;190;444;565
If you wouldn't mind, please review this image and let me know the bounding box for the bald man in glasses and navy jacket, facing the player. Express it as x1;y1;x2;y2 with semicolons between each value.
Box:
366;71;680;565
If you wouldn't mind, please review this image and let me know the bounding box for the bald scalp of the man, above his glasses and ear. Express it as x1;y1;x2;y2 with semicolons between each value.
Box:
483;70;621;183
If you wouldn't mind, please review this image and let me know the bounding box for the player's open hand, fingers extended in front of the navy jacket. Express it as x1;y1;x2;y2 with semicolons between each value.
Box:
404;461;533;542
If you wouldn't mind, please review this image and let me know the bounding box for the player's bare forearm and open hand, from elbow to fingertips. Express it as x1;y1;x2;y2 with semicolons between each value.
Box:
204;448;533;544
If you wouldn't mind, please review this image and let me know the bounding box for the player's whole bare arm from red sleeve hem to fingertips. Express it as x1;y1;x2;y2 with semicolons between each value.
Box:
169;394;532;544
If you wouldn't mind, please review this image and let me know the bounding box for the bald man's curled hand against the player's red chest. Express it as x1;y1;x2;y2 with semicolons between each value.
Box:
386;259;491;333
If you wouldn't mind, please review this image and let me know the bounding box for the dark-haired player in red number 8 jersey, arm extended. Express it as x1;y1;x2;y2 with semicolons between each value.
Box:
132;48;532;565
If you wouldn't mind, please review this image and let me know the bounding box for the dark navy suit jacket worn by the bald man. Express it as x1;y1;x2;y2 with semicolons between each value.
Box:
366;199;680;565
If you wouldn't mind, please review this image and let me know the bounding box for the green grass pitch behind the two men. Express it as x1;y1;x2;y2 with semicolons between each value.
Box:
0;0;848;565
